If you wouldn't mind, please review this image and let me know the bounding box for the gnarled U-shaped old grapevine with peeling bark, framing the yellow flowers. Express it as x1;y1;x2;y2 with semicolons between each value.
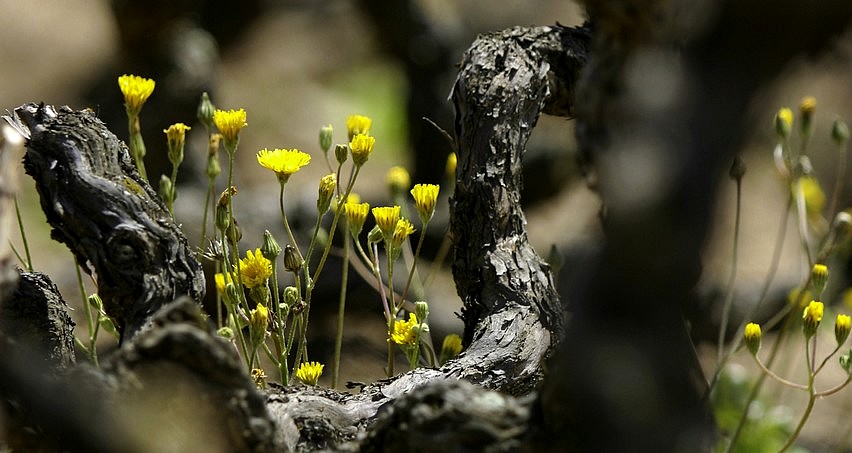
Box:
0;26;588;451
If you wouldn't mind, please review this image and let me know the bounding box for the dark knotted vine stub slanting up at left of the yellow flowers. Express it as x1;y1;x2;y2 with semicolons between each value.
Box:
9;104;204;339
